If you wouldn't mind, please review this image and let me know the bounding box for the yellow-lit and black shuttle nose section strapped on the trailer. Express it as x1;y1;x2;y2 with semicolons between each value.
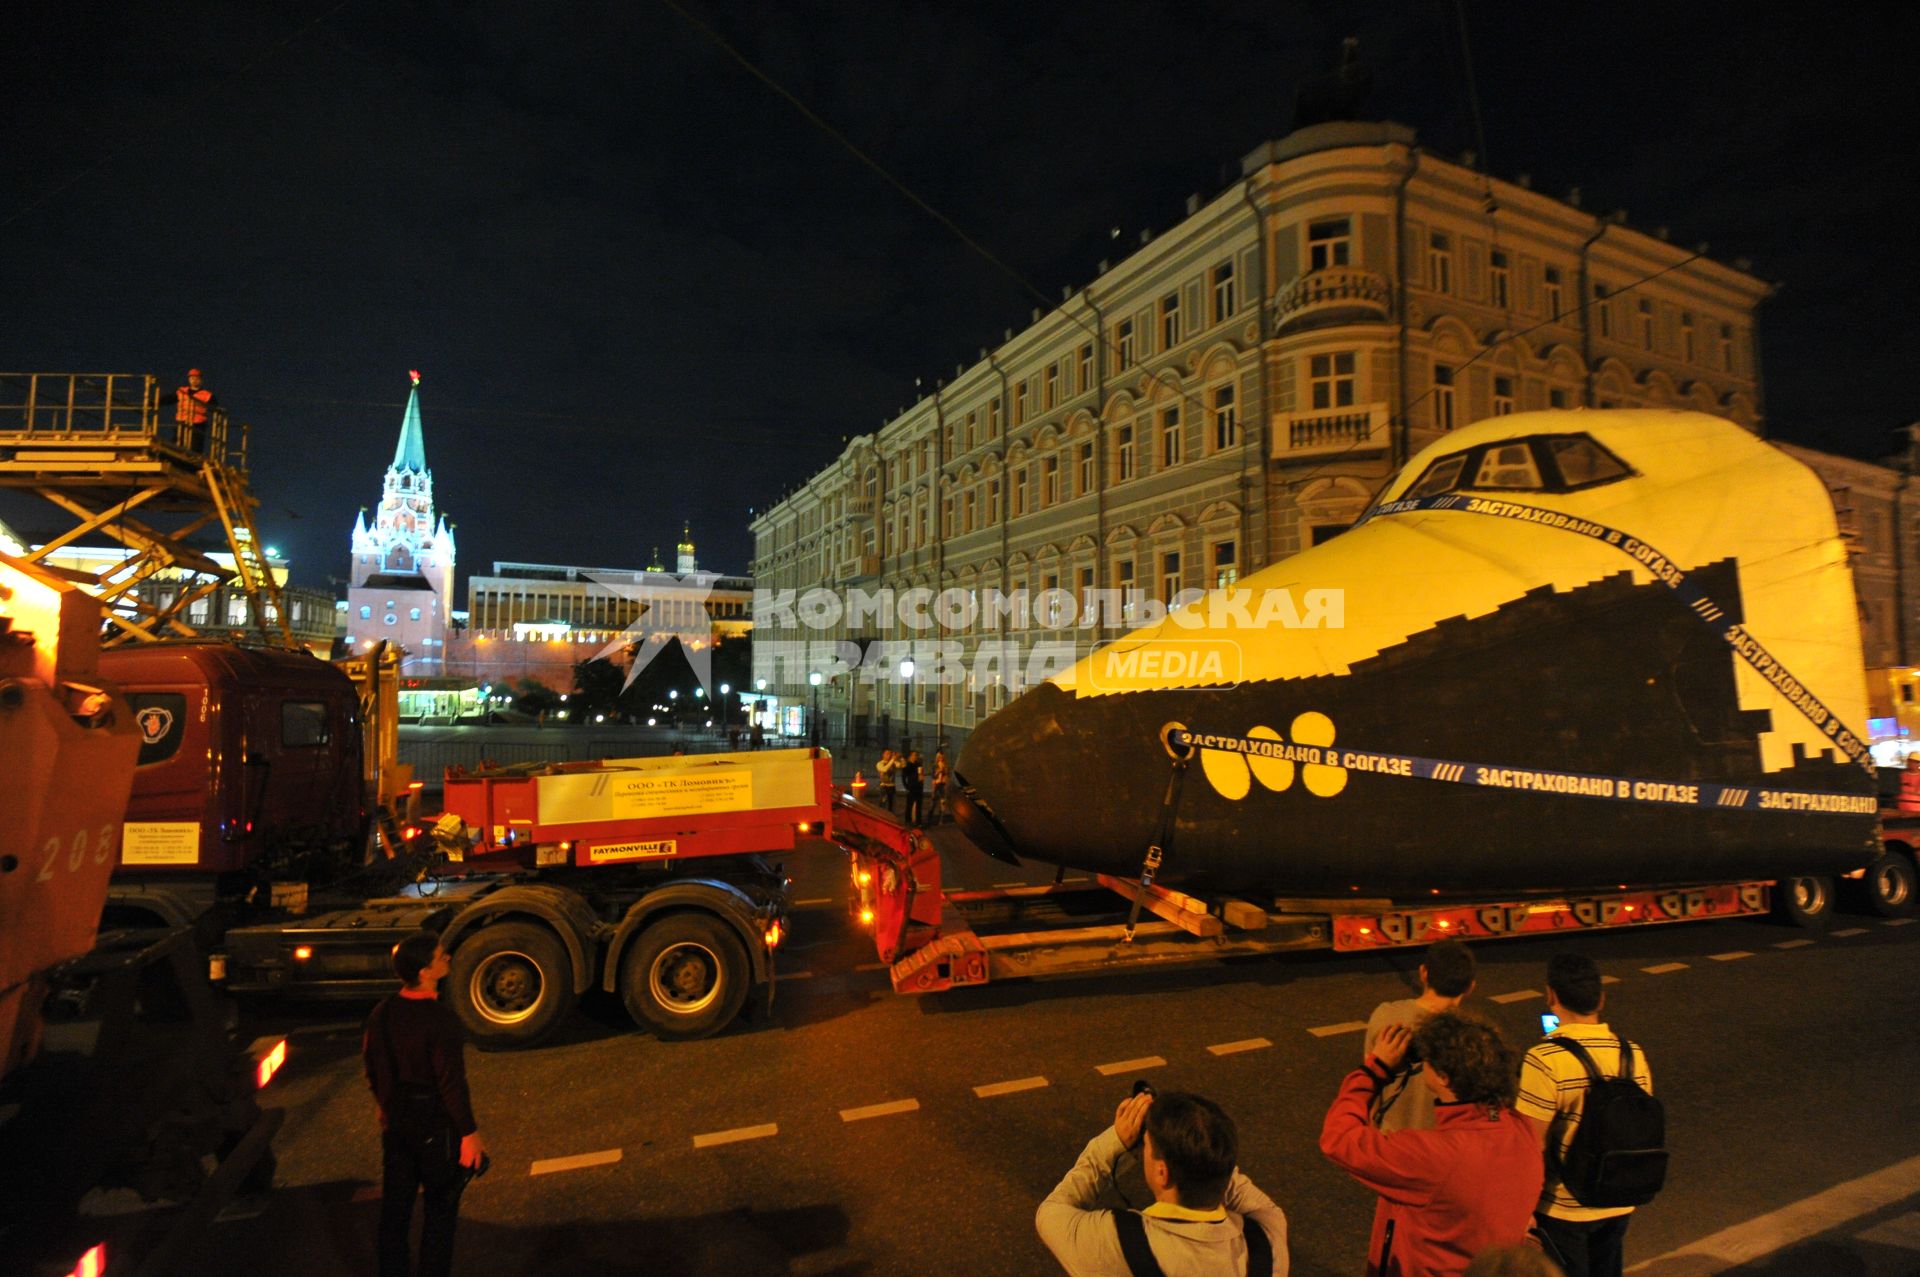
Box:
956;411;1876;897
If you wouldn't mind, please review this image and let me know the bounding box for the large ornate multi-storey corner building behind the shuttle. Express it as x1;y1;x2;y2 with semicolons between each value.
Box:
753;123;1768;741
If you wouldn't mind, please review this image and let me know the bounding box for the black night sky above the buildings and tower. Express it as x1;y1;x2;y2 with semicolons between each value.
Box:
0;0;1920;591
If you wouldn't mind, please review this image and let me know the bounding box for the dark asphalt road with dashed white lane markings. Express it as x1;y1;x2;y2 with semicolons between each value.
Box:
204;837;1920;1277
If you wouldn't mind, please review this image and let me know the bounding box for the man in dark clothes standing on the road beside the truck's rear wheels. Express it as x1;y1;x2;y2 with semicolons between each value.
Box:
361;931;488;1277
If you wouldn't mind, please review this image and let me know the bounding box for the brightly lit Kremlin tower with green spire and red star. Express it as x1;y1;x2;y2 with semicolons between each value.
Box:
348;373;453;676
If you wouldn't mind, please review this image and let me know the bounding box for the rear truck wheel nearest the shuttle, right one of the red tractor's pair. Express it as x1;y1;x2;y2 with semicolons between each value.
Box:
620;914;747;1041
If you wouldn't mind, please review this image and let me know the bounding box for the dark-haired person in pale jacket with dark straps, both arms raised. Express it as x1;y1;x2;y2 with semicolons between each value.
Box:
1033;1083;1288;1277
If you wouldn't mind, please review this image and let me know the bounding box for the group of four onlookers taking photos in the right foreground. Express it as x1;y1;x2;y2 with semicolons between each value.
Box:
1035;941;1667;1277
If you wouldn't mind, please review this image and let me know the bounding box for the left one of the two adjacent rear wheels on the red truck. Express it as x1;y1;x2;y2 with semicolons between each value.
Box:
445;922;574;1050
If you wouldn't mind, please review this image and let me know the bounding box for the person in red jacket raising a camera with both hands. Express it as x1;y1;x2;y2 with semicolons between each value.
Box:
1321;1010;1546;1277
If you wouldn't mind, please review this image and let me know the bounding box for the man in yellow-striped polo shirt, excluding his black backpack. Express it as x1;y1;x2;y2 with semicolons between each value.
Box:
1513;952;1653;1277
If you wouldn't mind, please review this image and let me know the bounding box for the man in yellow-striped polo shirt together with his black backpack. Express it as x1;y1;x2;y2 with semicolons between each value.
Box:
1515;952;1667;1277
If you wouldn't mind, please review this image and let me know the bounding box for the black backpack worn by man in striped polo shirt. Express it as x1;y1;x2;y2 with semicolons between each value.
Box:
1553;1037;1667;1208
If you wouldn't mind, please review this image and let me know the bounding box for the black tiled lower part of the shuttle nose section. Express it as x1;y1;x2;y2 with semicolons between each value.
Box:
958;563;1874;895
